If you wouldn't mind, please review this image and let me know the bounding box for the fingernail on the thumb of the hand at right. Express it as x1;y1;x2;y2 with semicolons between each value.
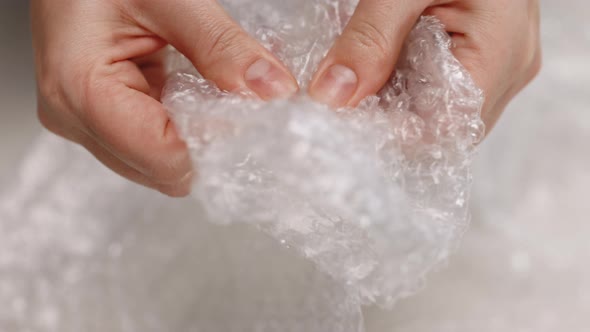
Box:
310;65;358;107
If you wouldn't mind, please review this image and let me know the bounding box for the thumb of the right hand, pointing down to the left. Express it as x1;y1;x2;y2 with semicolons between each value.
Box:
309;0;427;107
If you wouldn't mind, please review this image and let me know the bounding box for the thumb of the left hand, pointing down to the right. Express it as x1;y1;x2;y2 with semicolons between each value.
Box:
138;0;298;99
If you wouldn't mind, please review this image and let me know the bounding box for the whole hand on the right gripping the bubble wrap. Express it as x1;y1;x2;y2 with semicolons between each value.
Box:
310;0;541;130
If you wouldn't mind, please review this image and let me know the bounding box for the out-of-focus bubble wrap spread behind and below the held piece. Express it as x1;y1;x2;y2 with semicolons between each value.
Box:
0;0;590;332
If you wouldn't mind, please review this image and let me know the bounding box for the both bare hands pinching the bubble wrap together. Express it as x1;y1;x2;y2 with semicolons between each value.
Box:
31;0;541;197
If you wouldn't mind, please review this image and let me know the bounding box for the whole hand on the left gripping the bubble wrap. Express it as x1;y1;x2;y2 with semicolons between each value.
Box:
32;0;298;196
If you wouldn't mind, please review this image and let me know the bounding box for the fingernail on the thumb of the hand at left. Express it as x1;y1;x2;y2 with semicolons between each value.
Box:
244;59;298;99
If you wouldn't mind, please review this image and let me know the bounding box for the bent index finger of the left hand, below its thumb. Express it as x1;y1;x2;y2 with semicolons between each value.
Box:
80;61;192;184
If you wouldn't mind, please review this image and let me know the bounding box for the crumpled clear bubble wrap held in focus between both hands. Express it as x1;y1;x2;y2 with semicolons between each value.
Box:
164;0;484;305
